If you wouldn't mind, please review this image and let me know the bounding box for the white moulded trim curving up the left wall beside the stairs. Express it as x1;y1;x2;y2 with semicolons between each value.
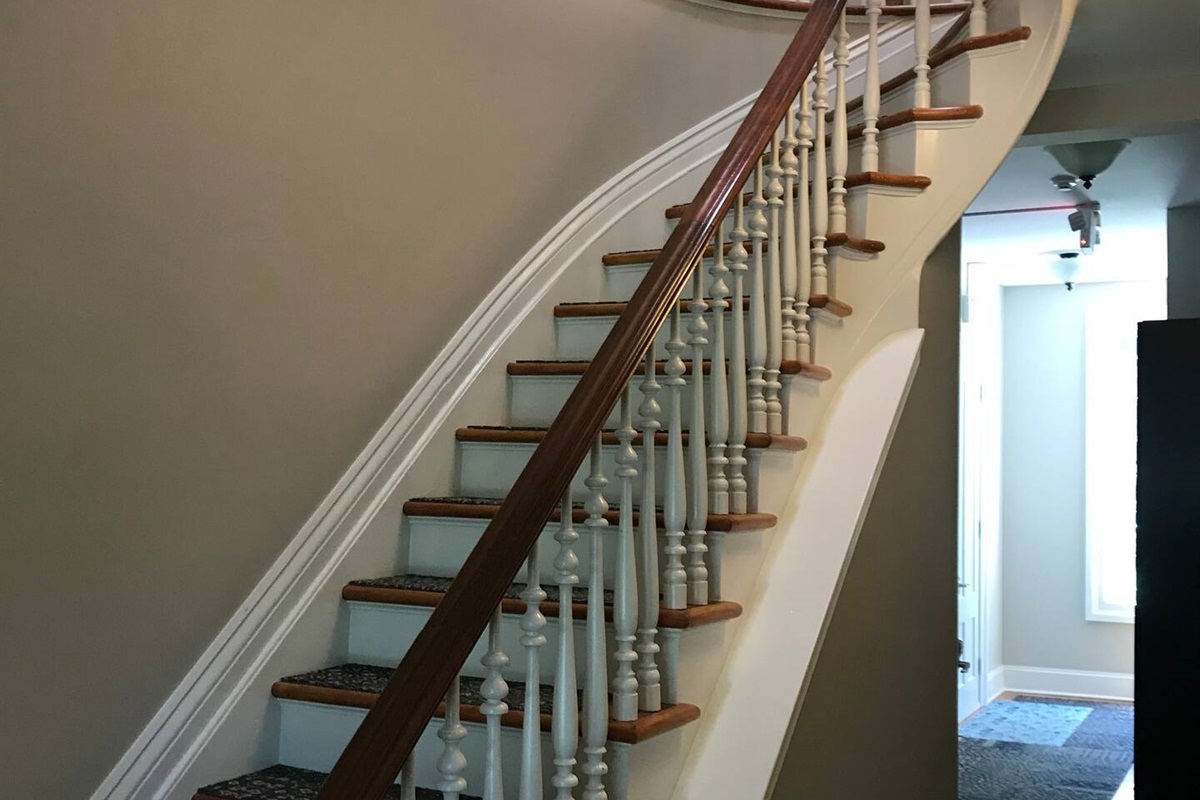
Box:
90;86;757;800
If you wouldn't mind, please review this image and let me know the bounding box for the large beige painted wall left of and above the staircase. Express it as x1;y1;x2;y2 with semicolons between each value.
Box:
0;0;794;798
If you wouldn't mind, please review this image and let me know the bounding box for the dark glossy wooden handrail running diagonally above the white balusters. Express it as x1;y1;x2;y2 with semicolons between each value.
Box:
318;0;846;800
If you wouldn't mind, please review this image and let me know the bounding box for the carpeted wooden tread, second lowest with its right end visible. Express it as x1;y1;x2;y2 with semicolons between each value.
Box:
342;575;742;628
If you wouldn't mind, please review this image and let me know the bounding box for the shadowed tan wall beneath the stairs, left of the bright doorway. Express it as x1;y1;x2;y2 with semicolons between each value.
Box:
773;227;960;800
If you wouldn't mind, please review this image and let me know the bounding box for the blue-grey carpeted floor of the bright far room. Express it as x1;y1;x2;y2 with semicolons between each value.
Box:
959;696;1133;800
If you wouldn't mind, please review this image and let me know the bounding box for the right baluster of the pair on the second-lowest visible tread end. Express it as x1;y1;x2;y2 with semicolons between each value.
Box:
688;263;705;606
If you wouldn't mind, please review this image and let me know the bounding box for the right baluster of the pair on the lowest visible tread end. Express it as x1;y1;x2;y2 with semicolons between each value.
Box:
637;342;662;711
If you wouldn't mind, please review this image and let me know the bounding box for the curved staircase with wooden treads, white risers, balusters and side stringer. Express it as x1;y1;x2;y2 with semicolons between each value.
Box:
194;0;1074;800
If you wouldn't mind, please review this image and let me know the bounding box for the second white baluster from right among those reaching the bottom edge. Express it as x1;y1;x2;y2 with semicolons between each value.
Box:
549;487;580;800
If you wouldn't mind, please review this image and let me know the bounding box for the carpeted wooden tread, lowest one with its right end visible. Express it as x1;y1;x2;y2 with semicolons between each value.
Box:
271;663;700;744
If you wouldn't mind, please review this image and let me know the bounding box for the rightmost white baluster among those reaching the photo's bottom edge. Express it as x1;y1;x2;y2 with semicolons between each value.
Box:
583;433;608;800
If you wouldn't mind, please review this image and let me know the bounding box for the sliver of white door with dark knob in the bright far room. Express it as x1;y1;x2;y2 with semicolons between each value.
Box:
955;291;994;721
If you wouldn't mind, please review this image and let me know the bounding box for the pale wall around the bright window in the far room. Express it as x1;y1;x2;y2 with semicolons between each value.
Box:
1002;281;1166;674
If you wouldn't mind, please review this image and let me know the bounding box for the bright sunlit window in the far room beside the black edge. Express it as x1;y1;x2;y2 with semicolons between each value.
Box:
1084;293;1165;622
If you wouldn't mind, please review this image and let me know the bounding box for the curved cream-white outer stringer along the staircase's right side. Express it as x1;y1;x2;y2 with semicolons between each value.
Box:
662;0;1078;800
